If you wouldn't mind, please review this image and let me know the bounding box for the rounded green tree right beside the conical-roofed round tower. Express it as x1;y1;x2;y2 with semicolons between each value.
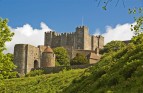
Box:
54;47;70;66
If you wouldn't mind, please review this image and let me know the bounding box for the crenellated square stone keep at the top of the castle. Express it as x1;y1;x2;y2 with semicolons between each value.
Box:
44;26;104;50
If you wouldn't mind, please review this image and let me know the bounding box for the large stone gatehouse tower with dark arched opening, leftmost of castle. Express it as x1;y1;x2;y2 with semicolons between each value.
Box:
14;44;40;74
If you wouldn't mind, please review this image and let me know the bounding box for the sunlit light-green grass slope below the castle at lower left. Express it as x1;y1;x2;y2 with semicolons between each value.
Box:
0;69;85;93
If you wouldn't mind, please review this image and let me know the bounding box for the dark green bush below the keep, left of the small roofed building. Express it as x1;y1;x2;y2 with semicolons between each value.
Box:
70;53;89;65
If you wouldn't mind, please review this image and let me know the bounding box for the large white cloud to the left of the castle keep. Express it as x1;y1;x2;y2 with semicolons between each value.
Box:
5;22;52;53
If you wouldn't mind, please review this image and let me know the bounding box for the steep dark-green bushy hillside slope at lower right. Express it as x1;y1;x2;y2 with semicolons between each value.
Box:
63;35;143;93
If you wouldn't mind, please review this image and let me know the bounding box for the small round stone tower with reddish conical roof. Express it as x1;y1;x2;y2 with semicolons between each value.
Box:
41;46;55;67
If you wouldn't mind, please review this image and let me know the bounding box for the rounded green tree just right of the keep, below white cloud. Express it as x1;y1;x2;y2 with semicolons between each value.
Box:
100;41;125;54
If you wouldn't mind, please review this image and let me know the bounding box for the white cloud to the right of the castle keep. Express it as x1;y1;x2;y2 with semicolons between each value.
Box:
95;23;135;44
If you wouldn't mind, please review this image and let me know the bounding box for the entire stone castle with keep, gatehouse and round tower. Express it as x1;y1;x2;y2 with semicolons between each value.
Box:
14;26;104;74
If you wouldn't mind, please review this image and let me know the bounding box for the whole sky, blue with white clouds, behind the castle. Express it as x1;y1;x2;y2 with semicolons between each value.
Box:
0;0;143;53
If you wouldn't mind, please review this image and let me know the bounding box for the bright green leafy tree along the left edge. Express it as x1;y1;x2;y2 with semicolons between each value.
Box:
0;18;16;79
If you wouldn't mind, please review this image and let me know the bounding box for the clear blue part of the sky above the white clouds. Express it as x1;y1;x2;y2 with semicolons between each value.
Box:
0;0;143;34
